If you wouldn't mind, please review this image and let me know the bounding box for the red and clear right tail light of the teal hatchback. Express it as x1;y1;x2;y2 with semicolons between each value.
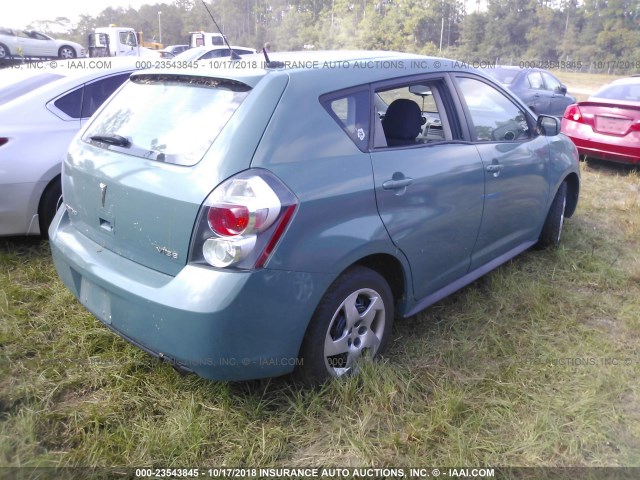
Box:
189;169;298;269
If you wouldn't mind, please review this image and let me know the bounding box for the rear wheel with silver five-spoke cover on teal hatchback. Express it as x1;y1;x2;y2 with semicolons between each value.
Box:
298;267;393;384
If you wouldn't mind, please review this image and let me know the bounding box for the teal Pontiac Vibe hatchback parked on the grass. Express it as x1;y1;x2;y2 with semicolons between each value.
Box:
49;52;580;382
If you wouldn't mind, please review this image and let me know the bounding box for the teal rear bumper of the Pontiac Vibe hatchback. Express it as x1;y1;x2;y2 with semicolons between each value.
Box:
49;209;334;380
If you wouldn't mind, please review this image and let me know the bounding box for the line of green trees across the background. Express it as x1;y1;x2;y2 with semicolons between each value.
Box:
32;0;640;74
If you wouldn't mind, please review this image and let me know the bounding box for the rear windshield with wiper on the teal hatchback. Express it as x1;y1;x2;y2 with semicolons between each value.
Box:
82;74;250;166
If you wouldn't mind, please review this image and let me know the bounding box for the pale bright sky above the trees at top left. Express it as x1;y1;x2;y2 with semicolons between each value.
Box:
5;0;160;28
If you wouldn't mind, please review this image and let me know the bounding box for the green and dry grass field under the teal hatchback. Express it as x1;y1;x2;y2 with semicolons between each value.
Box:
0;159;640;467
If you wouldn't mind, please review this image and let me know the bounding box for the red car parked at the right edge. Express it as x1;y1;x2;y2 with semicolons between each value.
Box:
561;77;640;164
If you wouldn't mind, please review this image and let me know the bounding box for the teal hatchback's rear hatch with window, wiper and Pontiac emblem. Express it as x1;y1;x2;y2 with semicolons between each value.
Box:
63;71;287;275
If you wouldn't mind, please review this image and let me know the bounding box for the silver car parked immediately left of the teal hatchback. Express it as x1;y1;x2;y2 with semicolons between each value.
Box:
0;59;141;236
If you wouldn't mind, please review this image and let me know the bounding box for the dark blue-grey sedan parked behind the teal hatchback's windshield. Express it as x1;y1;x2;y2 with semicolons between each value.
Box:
483;66;576;118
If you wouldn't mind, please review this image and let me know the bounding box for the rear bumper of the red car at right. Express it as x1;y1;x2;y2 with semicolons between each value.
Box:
561;118;640;164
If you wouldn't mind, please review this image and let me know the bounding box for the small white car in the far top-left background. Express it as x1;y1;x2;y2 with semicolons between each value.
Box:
0;27;85;60
